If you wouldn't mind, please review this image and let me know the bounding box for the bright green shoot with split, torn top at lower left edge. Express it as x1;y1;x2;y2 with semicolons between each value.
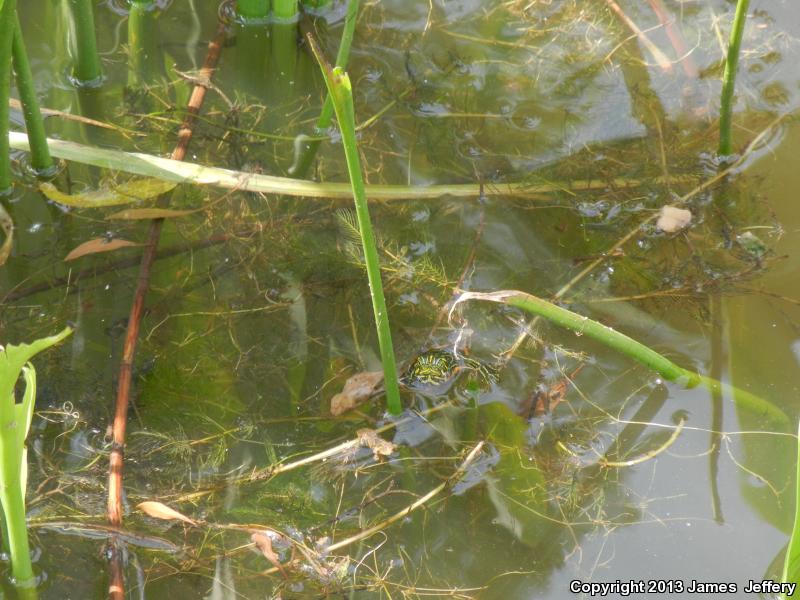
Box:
0;327;72;587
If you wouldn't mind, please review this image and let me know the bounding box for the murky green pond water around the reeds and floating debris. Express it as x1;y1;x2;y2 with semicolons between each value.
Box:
0;0;800;600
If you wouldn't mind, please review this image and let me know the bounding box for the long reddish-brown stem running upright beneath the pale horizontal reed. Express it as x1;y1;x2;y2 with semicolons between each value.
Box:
107;24;225;600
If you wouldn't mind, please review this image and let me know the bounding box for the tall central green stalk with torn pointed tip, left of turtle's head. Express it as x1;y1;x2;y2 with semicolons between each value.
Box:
308;36;402;415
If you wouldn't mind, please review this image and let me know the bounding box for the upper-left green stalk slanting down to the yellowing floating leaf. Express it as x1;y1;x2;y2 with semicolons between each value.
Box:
12;14;53;174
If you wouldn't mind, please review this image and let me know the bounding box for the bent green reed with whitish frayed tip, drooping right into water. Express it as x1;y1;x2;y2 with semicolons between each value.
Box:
456;291;789;429
